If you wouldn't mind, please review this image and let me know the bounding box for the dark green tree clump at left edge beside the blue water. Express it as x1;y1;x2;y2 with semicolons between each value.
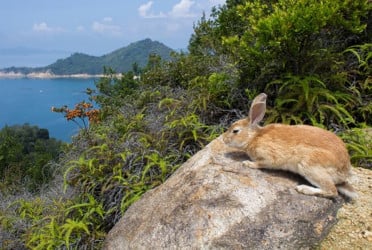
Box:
0;124;62;192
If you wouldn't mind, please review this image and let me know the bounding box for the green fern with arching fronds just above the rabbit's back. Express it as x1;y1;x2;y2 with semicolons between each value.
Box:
268;75;356;127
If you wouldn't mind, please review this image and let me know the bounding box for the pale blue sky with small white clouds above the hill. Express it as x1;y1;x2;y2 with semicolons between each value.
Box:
0;0;225;68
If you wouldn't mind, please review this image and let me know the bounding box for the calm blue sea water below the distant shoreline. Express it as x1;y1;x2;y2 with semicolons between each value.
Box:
0;79;95;142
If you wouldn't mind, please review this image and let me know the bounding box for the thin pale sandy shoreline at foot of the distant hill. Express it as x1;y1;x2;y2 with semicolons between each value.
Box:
0;71;104;79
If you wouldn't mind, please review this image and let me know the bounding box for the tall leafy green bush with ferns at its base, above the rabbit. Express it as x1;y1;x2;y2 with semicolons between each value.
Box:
190;0;371;126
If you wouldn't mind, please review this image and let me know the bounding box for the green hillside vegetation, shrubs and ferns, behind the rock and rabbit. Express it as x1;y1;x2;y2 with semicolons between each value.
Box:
0;0;372;249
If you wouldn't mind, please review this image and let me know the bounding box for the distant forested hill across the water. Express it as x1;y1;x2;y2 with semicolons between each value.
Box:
1;39;173;75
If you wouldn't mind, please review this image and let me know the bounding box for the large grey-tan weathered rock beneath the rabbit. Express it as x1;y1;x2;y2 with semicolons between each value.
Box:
105;138;343;250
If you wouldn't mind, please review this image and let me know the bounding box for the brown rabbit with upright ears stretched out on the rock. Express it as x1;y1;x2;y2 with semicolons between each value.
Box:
223;93;357;199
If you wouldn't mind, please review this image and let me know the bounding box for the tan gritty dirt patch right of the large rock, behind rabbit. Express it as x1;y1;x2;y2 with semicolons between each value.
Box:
319;168;372;250
